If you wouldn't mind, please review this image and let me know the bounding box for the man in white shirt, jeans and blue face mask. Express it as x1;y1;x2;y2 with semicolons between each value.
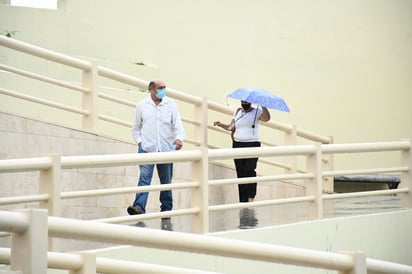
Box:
127;80;185;220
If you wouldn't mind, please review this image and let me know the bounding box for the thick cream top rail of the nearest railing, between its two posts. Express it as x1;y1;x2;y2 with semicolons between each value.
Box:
48;214;353;271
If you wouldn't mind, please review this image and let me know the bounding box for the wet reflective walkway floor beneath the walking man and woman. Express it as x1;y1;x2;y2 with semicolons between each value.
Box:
55;195;401;251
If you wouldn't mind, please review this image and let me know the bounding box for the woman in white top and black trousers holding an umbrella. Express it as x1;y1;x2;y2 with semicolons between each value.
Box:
213;100;270;203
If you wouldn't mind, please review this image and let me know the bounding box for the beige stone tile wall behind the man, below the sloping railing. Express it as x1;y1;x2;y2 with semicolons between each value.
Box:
0;112;303;233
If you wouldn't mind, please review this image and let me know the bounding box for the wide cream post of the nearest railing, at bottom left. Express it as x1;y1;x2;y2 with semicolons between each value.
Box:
10;209;48;274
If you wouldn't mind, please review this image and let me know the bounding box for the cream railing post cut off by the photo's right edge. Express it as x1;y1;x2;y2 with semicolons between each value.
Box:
400;139;412;208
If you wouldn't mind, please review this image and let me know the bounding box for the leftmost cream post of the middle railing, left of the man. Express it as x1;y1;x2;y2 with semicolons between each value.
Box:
39;154;61;250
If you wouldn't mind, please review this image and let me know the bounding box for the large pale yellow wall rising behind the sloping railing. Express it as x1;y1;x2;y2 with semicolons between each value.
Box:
0;0;412;169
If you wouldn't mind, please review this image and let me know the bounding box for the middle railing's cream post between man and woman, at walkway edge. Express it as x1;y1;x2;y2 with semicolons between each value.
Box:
191;147;209;234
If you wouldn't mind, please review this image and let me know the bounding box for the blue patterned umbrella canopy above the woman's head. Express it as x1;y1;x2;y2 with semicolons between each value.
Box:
227;88;289;112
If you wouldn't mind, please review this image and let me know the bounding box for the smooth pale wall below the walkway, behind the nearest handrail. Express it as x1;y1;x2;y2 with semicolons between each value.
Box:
93;210;412;274
